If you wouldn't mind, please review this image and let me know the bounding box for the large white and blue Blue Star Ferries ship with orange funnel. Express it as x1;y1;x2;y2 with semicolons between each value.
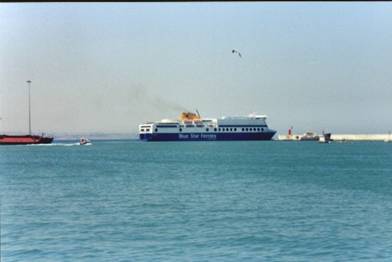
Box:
139;112;276;141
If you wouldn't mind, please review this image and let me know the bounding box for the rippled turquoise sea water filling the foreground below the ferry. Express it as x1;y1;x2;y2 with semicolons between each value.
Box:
0;141;392;262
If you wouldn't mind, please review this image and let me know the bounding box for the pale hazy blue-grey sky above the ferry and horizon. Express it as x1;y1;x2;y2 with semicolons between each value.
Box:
0;2;392;133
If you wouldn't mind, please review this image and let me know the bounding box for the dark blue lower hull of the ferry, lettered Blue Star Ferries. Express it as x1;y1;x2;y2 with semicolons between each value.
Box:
139;132;276;141
